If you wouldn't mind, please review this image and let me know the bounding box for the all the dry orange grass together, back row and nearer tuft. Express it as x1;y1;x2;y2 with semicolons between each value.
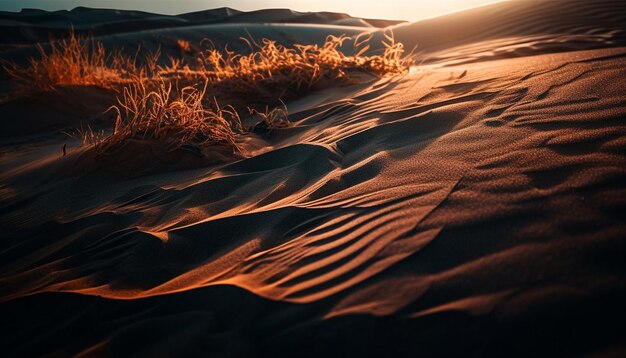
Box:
3;32;411;151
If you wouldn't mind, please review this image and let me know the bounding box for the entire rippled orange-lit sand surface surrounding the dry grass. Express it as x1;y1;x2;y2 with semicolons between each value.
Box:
0;0;626;357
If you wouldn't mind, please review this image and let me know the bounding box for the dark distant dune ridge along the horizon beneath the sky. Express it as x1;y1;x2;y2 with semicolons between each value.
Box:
0;7;402;47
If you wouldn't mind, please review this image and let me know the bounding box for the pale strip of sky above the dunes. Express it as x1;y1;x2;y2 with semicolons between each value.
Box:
0;0;501;21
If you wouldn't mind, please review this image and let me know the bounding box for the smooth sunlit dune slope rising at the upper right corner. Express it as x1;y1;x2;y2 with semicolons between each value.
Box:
393;0;626;63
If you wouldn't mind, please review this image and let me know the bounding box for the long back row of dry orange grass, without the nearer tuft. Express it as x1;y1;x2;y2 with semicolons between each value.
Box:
2;31;411;96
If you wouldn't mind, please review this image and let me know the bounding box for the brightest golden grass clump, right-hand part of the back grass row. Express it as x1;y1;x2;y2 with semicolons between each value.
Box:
157;32;412;101
